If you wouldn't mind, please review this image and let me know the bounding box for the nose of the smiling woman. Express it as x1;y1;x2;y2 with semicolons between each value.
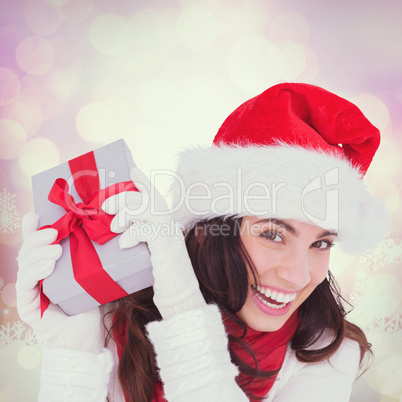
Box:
276;249;311;289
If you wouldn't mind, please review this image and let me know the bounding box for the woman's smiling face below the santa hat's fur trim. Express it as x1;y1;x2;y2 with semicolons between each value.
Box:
237;216;336;332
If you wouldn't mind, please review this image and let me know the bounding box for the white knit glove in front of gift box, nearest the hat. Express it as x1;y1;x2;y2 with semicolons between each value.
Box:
102;168;205;319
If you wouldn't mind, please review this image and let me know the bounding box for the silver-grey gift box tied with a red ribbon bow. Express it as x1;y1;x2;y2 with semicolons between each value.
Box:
32;139;154;315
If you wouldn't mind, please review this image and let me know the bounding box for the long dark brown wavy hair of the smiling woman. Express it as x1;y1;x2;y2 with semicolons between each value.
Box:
108;218;372;401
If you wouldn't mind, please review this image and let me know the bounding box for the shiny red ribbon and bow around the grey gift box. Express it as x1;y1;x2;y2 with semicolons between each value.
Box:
40;152;138;315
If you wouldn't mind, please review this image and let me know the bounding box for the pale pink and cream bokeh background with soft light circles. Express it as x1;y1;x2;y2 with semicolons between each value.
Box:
0;0;402;402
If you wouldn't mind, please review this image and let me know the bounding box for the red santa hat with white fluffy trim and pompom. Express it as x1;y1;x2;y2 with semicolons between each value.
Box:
171;83;387;253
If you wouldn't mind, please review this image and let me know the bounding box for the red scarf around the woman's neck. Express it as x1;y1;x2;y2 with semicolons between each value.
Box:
113;311;300;402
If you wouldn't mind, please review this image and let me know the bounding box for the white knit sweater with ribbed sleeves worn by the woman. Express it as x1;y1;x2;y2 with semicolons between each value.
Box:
39;305;359;402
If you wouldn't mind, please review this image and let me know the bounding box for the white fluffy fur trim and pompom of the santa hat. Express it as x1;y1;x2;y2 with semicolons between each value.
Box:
171;144;387;253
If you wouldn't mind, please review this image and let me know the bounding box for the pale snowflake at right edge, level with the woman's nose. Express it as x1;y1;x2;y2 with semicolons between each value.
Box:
360;237;402;271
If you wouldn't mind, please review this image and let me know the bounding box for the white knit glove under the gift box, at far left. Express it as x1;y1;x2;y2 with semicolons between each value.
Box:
16;214;101;353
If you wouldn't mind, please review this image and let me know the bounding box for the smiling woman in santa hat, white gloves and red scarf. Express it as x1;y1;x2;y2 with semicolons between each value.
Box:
17;84;386;401
